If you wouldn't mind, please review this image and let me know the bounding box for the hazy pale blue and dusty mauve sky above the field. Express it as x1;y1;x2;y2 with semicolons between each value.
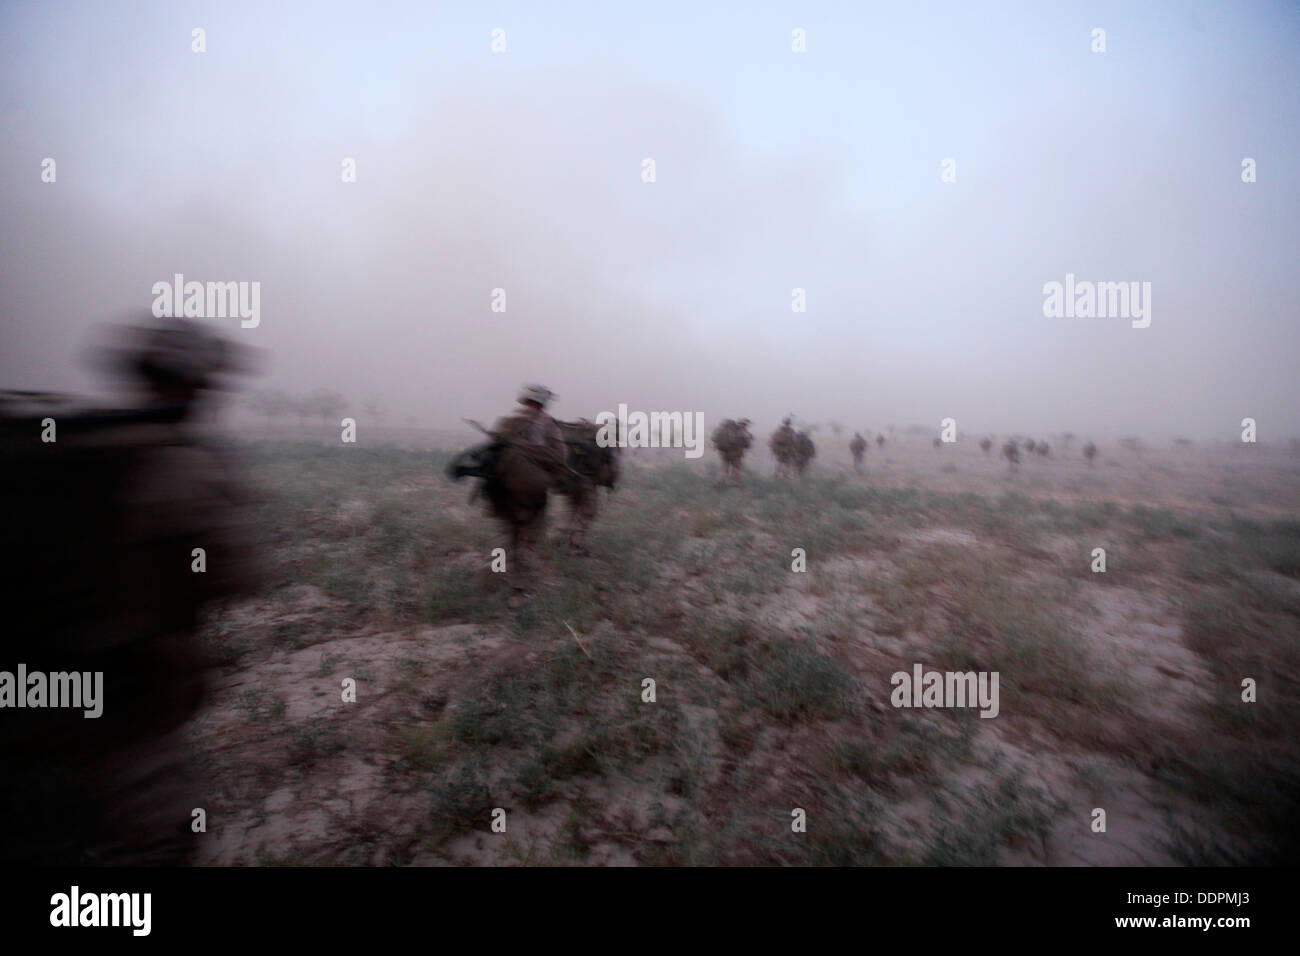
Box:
0;0;1300;441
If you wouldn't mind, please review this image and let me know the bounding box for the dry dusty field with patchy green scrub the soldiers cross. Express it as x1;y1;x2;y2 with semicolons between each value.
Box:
192;445;1300;865
